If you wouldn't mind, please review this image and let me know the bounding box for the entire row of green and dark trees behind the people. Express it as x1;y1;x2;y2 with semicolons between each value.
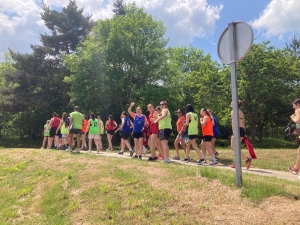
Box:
0;0;300;141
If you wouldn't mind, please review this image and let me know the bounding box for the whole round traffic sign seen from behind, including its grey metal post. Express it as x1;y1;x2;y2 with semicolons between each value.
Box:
218;22;253;187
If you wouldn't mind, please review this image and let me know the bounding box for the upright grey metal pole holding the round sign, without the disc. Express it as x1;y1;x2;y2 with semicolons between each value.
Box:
228;22;242;187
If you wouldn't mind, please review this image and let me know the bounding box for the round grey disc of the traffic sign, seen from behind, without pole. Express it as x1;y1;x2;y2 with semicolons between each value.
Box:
218;22;254;64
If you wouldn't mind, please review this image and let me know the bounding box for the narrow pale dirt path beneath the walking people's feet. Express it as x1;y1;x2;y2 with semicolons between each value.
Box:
81;151;300;182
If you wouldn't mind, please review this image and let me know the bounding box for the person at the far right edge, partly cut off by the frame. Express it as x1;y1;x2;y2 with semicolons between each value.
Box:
289;99;300;175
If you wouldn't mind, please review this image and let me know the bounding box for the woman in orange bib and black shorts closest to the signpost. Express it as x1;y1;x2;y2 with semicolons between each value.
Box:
198;109;218;165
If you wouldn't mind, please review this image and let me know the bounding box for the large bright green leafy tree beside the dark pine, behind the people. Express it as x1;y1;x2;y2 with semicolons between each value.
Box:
65;4;167;116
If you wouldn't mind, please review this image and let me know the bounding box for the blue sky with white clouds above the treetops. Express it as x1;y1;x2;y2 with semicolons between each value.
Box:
0;0;300;60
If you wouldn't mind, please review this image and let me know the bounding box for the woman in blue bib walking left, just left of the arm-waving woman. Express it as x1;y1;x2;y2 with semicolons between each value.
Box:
118;111;133;155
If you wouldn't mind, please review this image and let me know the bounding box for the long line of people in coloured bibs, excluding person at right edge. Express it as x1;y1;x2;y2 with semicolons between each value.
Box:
42;101;251;169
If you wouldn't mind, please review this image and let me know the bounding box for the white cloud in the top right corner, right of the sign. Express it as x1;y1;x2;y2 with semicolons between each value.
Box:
252;0;300;38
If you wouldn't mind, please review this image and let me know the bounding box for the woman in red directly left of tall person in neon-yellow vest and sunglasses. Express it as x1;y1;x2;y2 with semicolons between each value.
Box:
147;104;158;161
